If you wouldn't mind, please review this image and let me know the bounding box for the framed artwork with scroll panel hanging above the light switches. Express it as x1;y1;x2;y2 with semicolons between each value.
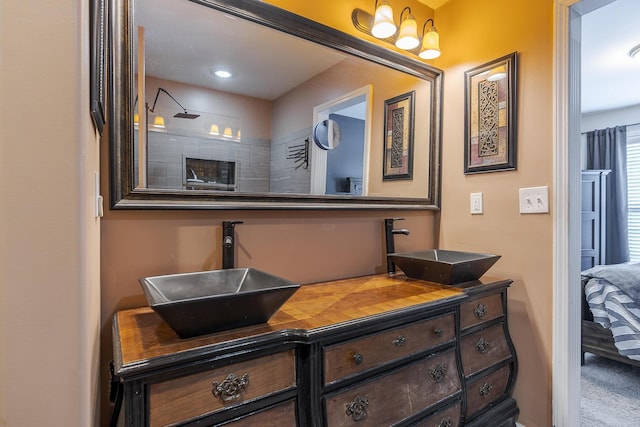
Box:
464;52;517;174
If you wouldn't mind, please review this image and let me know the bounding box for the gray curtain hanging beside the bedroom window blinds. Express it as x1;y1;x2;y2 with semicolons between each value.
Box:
586;126;629;264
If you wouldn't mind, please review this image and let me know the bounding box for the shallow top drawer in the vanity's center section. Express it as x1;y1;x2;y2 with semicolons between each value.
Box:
324;314;455;384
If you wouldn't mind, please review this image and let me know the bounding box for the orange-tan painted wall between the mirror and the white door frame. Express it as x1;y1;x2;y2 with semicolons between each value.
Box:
435;0;553;427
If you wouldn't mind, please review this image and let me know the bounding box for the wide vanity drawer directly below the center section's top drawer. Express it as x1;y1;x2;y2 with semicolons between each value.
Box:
325;349;460;427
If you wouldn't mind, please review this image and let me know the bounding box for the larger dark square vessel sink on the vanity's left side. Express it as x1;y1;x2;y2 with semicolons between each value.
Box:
140;268;300;338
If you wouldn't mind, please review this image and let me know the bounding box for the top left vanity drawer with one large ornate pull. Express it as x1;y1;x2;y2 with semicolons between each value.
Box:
149;350;296;426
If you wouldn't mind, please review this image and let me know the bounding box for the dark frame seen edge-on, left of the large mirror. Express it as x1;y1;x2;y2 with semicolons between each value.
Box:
89;0;107;135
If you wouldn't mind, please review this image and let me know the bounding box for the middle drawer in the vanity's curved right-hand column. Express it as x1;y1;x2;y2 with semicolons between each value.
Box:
460;323;511;376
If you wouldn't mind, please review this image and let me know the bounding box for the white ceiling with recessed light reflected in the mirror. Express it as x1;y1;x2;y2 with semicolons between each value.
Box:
135;0;345;100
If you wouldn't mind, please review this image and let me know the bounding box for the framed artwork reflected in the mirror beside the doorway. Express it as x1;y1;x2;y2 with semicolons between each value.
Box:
382;91;415;181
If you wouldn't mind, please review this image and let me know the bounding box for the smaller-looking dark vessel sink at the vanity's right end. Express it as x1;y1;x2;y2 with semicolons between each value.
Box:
387;249;500;285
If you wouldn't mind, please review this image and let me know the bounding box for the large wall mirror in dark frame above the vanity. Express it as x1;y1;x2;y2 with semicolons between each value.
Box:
109;0;442;209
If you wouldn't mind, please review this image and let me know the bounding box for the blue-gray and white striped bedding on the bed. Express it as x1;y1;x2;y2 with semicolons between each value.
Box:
581;263;640;361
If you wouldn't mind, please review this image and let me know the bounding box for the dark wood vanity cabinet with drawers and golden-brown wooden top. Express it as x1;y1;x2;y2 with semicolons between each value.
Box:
114;275;518;427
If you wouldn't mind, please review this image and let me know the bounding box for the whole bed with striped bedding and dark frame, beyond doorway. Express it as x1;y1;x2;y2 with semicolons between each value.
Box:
581;263;640;366
